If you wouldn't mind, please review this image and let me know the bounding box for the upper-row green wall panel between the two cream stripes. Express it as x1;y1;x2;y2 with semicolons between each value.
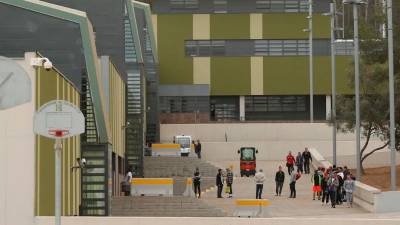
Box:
210;14;250;39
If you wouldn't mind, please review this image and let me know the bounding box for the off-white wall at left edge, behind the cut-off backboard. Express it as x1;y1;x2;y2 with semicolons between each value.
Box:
0;53;35;225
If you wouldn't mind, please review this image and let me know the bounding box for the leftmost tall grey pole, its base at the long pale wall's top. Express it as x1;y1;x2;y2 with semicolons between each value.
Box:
308;0;314;123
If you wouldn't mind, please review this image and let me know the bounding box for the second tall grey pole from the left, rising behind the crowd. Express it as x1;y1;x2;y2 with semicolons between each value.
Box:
330;3;337;165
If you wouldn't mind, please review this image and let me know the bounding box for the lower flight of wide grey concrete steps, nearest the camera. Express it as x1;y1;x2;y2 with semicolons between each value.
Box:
111;196;227;217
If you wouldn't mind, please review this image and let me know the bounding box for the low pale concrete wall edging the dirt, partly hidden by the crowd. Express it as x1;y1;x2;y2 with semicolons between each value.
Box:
310;148;400;213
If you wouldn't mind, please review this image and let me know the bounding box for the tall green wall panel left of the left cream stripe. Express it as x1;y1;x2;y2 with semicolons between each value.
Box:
157;14;193;84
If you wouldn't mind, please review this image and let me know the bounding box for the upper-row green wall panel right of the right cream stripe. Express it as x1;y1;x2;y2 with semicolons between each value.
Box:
263;13;330;39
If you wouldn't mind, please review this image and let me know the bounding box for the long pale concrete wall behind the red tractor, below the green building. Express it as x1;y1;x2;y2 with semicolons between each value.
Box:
161;123;390;163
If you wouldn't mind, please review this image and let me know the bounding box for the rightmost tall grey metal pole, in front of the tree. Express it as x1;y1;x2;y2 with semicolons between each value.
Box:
386;0;397;191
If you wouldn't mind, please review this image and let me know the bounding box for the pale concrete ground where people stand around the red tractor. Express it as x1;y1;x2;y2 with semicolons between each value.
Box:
202;161;367;217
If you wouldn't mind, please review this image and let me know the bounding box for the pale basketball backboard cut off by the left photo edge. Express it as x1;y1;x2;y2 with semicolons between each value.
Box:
0;56;32;110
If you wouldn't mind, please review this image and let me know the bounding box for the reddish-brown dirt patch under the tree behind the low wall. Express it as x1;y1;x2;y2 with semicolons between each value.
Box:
351;166;400;191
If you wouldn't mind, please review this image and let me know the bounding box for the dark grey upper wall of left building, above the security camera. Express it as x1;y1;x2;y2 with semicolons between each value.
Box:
0;4;85;89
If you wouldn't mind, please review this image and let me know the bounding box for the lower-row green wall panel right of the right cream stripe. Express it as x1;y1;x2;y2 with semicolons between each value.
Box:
264;56;351;95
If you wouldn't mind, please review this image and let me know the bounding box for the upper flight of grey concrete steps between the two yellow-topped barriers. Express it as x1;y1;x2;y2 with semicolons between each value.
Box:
144;157;218;178
